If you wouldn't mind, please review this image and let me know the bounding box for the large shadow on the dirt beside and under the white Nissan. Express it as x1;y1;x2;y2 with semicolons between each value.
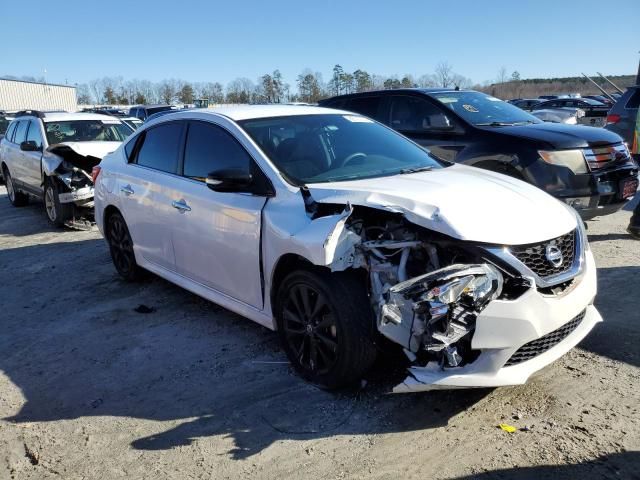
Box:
0;239;490;459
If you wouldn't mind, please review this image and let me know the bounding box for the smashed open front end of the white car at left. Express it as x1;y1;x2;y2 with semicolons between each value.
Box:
42;144;101;230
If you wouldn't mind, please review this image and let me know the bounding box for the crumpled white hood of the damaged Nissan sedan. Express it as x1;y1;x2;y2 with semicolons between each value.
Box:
308;165;577;245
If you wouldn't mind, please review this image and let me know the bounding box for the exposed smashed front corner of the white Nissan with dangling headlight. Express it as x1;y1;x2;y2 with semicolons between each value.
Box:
320;207;504;368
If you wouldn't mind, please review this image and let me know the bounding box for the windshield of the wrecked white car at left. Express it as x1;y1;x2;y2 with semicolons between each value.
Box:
45;119;131;145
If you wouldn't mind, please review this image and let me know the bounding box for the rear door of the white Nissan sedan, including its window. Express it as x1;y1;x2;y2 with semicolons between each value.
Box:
116;121;186;271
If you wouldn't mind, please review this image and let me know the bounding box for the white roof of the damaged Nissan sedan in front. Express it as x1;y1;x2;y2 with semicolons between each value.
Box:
158;105;358;121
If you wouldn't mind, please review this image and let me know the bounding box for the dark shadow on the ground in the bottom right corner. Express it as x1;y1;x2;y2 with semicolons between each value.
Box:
456;452;640;480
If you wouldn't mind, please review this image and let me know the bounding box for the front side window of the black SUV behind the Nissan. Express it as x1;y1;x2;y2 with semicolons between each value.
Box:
390;96;453;132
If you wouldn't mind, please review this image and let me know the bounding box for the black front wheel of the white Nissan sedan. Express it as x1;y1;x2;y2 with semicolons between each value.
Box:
276;270;376;389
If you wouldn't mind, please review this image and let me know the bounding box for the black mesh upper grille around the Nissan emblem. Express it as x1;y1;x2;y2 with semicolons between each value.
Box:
510;230;576;278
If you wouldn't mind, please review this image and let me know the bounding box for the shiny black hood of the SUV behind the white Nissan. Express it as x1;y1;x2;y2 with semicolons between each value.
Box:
490;123;622;150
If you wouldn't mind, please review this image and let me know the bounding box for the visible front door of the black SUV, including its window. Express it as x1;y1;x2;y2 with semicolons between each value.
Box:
386;95;464;161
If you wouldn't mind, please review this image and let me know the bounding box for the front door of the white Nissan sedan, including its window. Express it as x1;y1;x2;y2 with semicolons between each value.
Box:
171;121;266;308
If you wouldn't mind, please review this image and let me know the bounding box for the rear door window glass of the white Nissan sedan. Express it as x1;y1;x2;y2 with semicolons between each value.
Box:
136;122;183;173
